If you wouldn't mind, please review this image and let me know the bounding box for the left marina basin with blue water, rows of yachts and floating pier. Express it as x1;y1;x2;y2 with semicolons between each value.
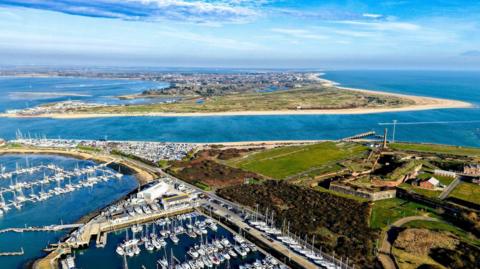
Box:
0;154;138;268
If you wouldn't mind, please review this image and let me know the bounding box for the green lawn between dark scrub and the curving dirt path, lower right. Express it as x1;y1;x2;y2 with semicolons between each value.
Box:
370;198;435;229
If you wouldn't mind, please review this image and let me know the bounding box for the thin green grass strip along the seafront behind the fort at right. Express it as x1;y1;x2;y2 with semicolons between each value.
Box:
389;143;480;156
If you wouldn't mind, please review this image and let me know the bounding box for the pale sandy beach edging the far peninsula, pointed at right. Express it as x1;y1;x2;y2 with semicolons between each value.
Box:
0;76;474;119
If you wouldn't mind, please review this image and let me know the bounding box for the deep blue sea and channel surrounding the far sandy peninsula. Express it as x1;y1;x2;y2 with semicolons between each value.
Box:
0;71;480;146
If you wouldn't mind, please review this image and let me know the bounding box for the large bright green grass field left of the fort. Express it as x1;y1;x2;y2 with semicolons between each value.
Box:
229;142;367;179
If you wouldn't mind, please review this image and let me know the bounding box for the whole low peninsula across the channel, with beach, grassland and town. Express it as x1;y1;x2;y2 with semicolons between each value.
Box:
0;72;471;118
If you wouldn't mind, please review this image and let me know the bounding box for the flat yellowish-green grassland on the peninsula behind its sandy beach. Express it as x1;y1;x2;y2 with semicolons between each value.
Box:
80;85;414;114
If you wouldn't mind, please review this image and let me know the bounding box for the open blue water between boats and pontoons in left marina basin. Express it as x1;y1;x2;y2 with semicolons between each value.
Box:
0;155;137;268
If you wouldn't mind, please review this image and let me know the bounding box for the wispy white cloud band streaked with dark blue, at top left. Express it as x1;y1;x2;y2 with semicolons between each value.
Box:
0;0;266;23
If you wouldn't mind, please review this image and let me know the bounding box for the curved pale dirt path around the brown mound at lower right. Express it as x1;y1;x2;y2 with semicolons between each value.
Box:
377;216;438;269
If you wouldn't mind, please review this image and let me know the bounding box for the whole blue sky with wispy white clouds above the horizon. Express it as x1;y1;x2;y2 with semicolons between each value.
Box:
0;0;480;69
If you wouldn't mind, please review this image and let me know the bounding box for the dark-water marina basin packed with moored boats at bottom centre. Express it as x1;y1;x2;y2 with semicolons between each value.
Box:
74;213;278;268
